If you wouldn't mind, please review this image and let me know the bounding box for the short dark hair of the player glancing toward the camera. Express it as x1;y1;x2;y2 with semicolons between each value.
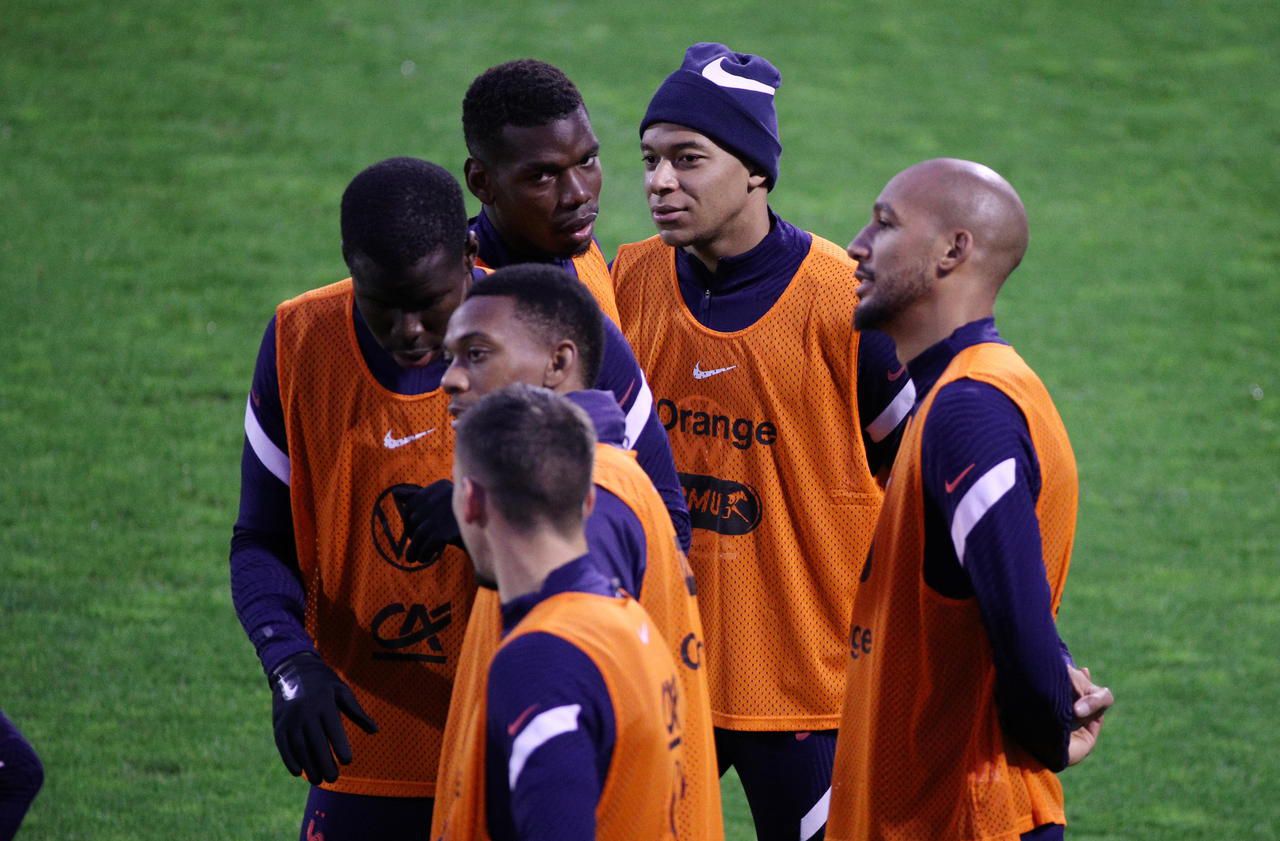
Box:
462;59;586;160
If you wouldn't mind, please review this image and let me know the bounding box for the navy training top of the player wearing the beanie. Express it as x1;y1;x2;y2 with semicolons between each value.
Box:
676;211;915;474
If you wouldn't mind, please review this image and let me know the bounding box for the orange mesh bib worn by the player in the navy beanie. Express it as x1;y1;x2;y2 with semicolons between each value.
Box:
613;237;881;731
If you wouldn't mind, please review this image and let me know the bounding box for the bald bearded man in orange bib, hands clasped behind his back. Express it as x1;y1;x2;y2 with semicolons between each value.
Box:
827;159;1110;841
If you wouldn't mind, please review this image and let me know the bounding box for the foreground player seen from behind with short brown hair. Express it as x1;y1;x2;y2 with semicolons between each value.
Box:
453;385;684;841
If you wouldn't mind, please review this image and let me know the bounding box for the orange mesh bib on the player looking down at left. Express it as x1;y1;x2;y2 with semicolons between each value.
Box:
276;280;475;796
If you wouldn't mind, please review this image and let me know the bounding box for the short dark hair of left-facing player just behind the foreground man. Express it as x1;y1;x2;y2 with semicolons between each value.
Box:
467;262;604;388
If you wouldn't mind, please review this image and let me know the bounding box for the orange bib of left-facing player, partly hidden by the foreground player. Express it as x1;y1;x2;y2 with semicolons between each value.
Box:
431;444;724;841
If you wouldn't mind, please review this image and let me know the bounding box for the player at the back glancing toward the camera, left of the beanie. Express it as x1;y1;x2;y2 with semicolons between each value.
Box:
462;59;689;549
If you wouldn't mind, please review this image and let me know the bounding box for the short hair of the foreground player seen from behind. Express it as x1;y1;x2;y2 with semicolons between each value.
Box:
456;383;595;533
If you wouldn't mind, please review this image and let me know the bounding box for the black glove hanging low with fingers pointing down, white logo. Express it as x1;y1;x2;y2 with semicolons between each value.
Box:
271;652;378;785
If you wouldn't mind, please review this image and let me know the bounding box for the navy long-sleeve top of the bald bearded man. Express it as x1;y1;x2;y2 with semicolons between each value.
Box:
910;319;1074;771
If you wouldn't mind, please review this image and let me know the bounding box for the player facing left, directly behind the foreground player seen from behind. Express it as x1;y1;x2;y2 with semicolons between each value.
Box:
431;264;723;841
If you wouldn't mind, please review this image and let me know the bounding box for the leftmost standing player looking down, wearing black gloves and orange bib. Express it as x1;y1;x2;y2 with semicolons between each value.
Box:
230;157;476;841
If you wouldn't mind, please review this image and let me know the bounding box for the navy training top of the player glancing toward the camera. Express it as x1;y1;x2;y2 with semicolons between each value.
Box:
471;210;692;552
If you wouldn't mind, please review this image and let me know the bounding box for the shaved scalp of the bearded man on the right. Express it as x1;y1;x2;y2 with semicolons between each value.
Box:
884;157;1029;283
